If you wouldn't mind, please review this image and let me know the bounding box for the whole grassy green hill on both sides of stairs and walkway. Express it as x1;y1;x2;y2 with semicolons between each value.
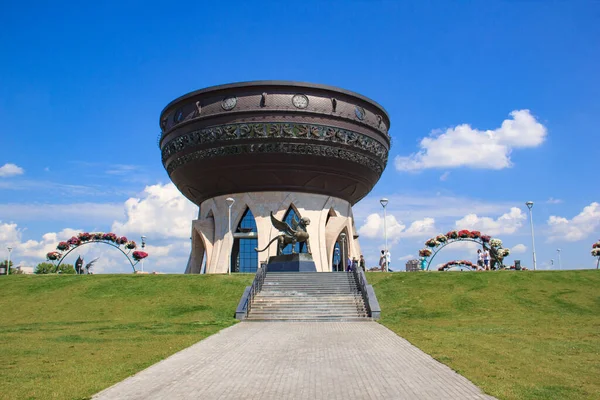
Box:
0;271;600;399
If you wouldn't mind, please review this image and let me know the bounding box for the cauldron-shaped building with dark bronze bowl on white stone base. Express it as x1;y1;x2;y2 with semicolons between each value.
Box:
159;81;390;273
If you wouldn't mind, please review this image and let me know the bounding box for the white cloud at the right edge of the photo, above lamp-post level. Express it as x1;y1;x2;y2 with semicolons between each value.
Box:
548;202;600;242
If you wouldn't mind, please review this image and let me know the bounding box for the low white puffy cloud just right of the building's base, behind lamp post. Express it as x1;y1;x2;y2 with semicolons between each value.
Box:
358;213;435;244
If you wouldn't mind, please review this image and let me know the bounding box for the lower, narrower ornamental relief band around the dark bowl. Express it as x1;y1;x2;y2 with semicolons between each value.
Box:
166;142;387;174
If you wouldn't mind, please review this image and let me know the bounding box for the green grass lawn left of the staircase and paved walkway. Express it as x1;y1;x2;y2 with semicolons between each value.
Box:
0;275;253;400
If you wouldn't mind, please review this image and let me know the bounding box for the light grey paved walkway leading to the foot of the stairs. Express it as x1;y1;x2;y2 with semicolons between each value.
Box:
94;322;493;400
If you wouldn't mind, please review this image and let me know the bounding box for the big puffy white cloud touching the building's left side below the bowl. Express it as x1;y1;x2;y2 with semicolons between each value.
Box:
112;183;198;239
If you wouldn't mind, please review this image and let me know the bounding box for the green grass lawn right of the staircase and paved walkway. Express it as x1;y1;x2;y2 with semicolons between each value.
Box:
367;270;600;399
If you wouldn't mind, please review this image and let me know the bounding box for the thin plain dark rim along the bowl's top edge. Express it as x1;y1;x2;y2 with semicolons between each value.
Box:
160;80;391;125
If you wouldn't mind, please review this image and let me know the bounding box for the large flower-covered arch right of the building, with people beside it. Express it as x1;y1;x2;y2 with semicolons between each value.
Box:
419;229;510;271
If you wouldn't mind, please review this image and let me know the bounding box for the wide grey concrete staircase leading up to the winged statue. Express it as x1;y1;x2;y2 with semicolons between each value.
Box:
247;272;370;321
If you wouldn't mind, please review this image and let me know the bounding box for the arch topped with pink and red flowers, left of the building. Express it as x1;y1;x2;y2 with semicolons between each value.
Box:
46;232;148;272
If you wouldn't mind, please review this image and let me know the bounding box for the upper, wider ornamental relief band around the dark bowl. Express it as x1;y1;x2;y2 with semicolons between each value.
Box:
162;123;388;165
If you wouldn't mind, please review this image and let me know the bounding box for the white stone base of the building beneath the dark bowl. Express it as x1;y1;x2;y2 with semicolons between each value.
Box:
185;192;360;274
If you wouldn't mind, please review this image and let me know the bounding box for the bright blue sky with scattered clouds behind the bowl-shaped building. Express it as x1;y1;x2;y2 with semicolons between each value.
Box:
0;1;600;272
